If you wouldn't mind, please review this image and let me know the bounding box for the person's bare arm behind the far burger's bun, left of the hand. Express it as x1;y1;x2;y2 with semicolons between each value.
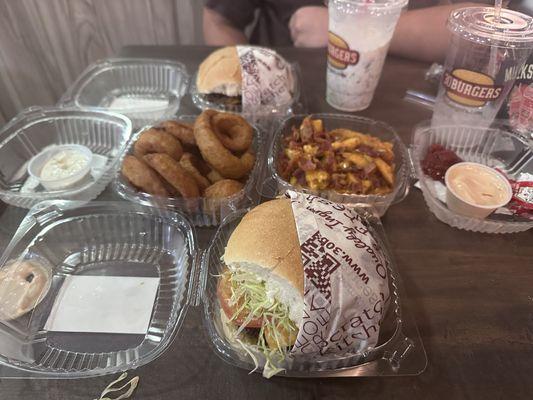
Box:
203;7;248;46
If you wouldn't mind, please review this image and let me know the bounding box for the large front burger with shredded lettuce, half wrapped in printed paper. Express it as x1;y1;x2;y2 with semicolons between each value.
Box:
218;192;389;377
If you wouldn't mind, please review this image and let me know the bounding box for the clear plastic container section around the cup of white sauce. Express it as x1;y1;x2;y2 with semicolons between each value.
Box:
0;107;131;208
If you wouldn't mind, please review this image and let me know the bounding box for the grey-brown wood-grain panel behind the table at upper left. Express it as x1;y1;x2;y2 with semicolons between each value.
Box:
0;0;202;124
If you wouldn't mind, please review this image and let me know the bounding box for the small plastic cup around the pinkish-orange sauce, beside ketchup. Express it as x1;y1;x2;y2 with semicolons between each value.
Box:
444;162;513;219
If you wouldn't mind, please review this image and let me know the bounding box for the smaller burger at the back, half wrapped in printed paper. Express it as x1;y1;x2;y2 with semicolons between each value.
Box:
196;46;294;114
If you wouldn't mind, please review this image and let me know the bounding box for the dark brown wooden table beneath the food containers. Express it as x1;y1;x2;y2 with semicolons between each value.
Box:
0;47;533;400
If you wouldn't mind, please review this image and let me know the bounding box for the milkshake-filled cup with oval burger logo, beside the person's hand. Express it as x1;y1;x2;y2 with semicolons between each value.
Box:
326;0;407;111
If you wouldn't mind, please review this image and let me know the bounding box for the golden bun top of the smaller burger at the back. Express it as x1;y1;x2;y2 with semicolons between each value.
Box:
196;46;242;96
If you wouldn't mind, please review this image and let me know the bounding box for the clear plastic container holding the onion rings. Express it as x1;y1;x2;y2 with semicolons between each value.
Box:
114;115;265;226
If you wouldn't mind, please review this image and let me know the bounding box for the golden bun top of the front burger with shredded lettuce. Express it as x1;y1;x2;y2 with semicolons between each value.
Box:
224;199;304;326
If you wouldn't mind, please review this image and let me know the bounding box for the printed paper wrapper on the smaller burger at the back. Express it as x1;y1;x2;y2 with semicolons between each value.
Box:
237;46;294;113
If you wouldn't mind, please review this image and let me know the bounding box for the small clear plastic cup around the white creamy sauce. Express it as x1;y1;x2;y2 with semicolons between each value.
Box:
28;144;93;191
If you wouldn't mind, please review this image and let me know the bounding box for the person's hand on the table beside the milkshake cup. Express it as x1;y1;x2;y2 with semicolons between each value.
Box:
289;6;328;47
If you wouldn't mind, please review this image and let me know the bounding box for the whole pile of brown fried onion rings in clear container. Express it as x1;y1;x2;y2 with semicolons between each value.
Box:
122;110;255;199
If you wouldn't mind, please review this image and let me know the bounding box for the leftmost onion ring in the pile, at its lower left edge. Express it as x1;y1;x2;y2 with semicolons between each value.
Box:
122;155;169;197
